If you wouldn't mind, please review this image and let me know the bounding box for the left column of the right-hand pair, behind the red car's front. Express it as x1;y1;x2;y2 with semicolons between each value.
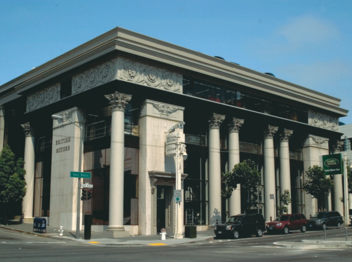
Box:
264;126;278;221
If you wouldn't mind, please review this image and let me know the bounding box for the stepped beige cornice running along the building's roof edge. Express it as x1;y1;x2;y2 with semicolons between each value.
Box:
0;27;348;116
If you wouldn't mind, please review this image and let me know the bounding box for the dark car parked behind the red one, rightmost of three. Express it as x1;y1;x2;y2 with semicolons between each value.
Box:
308;211;343;230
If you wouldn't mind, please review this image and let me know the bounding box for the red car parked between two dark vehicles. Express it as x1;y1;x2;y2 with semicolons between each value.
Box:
266;214;308;234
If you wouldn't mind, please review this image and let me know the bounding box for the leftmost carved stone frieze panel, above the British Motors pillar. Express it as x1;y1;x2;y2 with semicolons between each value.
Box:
26;83;60;112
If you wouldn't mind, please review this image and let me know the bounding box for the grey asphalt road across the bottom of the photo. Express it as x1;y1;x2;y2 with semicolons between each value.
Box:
0;229;352;262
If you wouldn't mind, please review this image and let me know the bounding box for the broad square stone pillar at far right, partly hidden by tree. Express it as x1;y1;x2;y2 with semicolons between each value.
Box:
303;135;329;218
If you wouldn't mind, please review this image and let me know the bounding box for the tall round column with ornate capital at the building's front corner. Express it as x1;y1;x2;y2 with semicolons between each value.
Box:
105;92;132;238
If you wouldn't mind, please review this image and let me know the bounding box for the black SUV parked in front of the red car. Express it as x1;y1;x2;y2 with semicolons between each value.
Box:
214;214;265;239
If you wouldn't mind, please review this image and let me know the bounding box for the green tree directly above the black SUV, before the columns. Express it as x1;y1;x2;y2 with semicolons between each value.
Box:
222;159;260;213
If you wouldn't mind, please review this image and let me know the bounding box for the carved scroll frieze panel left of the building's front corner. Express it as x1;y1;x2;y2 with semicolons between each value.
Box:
72;59;117;95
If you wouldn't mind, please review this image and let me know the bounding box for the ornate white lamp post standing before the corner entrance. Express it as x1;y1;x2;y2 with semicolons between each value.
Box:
165;121;187;239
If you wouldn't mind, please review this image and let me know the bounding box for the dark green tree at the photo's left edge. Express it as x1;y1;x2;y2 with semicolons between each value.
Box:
0;145;26;223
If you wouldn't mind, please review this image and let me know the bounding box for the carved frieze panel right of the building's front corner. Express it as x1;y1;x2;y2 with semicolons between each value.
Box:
117;58;182;93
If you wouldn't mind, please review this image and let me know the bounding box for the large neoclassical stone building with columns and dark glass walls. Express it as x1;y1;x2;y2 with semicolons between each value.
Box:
0;28;348;235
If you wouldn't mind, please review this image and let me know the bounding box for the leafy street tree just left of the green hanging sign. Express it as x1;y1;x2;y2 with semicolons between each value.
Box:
303;166;334;210
